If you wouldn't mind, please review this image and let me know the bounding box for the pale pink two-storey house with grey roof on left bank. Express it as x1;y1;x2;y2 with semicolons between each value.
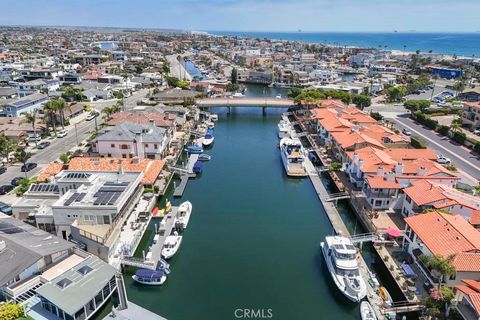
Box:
92;122;169;159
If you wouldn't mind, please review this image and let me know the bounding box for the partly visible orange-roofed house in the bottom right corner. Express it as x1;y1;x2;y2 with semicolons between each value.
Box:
455;279;480;320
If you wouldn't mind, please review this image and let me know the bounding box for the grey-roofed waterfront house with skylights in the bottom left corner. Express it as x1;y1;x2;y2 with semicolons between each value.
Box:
0;213;116;320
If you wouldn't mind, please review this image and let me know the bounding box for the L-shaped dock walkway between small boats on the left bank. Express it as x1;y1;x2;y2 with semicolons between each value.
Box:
122;207;178;270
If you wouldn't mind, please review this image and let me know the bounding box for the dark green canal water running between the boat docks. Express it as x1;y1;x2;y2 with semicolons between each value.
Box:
94;86;402;320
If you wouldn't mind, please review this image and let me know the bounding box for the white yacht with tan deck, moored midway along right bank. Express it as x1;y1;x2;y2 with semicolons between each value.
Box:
280;138;308;177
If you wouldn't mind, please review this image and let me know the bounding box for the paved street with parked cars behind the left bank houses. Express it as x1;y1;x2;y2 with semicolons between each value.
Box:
0;89;148;191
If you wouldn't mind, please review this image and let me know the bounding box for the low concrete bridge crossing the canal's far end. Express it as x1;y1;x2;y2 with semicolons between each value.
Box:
196;97;295;110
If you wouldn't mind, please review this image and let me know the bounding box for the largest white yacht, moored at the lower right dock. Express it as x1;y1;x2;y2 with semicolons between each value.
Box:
320;236;367;302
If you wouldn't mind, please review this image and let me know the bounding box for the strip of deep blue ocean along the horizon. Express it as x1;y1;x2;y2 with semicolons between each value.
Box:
208;31;480;57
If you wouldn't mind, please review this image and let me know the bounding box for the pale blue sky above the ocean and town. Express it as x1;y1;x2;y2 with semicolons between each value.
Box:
0;0;480;32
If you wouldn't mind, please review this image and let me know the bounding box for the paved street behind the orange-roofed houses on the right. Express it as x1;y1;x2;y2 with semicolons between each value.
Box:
392;114;480;183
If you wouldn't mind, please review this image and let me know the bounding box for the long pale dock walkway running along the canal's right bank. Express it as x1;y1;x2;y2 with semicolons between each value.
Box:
289;121;384;319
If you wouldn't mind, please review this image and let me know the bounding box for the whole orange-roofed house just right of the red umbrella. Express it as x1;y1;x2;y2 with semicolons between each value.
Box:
402;211;480;287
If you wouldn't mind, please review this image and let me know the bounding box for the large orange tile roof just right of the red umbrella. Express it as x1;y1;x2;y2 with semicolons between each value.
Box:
405;211;480;257
